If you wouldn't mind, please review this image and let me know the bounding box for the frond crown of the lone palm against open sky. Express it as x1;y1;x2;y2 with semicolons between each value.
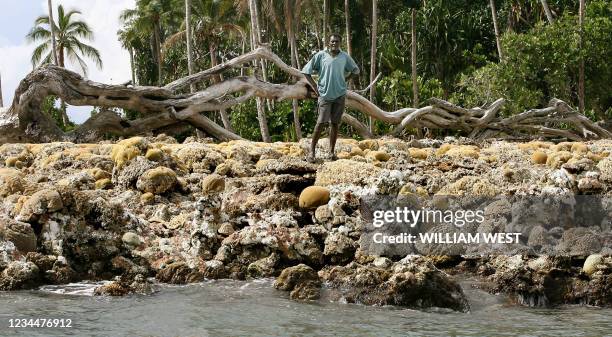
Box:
26;5;102;75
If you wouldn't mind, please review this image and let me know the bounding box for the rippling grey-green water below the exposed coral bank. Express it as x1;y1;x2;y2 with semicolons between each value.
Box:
0;279;612;337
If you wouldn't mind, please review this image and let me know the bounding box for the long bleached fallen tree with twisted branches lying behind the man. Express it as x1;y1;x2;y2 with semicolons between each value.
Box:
0;47;612;143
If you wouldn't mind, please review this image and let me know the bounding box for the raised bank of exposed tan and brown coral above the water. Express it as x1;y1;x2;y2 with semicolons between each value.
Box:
0;135;612;311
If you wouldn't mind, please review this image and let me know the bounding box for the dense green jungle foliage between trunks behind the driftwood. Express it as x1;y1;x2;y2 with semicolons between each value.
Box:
113;0;612;141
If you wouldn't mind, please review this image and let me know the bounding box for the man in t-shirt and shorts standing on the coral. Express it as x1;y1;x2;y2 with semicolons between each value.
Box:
302;34;359;162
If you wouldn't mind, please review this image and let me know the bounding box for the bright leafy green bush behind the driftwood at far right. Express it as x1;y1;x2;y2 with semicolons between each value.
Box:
453;1;612;115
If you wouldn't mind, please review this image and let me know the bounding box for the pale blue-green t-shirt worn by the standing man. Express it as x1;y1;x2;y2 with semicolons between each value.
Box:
302;50;359;101
